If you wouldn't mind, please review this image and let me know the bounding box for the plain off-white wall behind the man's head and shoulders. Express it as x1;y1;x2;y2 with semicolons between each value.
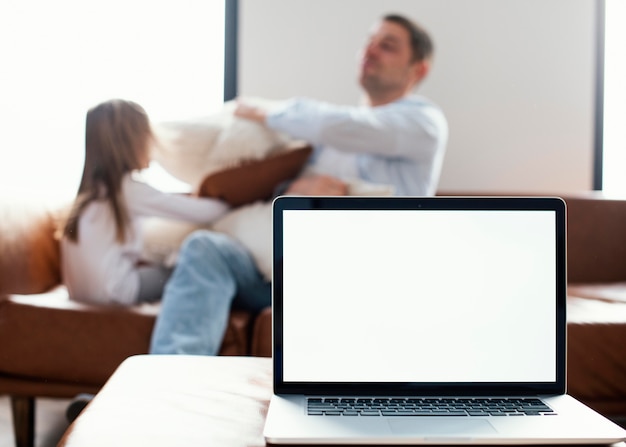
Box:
239;0;595;193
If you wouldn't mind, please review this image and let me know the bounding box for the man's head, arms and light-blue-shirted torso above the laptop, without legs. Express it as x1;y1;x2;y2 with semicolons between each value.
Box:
235;15;447;195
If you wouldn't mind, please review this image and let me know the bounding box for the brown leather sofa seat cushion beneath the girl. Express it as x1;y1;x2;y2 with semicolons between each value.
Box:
0;286;251;386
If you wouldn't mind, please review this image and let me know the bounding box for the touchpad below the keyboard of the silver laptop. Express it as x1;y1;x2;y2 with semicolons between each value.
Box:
388;417;496;438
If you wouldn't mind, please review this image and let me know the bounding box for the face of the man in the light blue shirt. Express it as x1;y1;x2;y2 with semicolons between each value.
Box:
359;21;420;100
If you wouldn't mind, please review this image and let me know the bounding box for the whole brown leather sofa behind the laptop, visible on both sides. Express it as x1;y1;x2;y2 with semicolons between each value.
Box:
0;192;626;446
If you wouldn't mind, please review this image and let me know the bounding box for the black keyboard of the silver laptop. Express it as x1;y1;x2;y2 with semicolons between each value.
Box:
307;397;556;416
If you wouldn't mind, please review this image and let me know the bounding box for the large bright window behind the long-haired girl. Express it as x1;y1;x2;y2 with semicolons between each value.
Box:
0;0;228;200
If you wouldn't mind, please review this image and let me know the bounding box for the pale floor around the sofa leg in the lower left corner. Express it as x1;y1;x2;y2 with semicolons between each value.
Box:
0;396;70;447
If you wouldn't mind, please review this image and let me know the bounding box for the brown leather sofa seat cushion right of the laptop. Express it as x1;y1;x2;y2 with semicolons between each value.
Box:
567;296;626;416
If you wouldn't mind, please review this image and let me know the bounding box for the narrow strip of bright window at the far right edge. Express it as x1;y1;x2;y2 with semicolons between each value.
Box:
597;0;626;195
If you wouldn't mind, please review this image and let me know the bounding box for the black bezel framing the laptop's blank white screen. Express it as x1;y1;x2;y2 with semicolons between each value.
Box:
272;196;567;396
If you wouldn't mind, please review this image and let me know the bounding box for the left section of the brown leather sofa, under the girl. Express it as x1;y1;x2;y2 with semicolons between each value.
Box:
0;203;254;446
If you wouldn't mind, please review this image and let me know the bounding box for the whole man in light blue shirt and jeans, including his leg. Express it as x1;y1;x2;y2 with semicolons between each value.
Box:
150;15;447;355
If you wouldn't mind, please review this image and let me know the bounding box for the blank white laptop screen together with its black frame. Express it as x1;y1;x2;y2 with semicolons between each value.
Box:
274;198;564;394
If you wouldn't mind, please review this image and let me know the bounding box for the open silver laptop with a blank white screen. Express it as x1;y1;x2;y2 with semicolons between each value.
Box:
264;196;626;445
